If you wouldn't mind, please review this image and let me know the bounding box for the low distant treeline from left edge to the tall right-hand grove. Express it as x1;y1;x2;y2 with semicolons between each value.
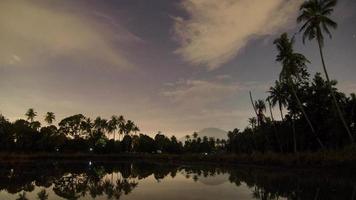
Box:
0;108;226;154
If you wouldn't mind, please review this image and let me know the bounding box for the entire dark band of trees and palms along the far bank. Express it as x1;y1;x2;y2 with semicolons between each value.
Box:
0;0;356;161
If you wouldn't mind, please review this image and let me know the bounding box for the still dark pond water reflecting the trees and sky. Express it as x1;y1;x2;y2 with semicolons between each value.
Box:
0;161;356;200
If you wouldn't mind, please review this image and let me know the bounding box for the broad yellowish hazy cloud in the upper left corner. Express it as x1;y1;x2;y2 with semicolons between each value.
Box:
0;0;138;69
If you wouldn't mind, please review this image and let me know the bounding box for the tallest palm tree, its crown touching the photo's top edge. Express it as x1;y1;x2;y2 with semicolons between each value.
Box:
297;0;354;143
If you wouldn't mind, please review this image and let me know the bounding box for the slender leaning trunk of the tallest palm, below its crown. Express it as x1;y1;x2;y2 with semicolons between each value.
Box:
317;37;354;144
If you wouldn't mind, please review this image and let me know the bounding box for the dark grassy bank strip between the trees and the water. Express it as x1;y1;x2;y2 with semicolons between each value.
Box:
0;152;356;169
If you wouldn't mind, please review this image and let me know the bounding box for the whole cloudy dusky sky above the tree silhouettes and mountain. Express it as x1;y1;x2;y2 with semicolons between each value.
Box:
0;0;356;136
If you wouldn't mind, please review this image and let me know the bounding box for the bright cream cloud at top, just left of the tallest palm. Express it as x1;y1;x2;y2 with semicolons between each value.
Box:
174;0;302;70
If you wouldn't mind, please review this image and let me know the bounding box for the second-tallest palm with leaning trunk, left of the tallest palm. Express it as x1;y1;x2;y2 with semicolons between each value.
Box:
274;33;324;148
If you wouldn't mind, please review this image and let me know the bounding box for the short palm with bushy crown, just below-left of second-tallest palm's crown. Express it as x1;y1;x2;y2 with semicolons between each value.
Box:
267;81;288;121
